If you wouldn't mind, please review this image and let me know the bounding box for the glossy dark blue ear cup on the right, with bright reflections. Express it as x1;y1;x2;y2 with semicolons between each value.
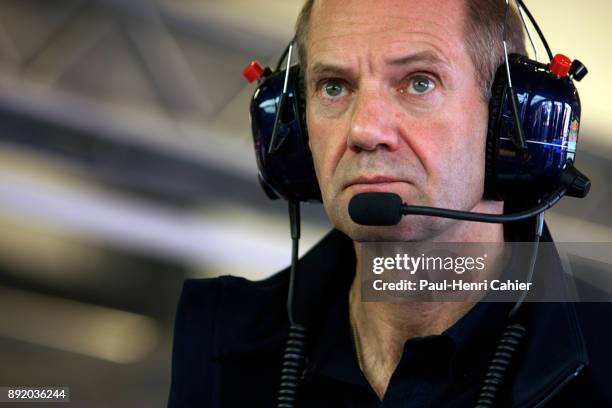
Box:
483;54;582;203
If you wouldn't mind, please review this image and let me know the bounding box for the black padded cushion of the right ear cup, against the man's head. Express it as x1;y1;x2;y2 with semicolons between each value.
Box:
484;64;508;200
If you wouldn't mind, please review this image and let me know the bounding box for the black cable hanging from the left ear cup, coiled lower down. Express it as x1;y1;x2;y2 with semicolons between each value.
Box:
276;201;308;408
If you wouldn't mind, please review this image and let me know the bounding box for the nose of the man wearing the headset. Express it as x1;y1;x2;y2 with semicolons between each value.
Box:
347;90;399;153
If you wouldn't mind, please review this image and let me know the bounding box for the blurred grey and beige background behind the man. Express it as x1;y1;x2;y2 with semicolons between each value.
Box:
0;0;612;407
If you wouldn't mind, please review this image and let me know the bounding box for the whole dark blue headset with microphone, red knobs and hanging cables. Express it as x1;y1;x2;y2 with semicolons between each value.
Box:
243;0;590;408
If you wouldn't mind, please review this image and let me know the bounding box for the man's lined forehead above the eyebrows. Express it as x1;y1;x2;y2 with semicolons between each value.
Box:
307;0;467;66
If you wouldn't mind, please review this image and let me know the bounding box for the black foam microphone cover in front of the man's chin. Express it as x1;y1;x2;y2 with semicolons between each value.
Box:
349;192;402;225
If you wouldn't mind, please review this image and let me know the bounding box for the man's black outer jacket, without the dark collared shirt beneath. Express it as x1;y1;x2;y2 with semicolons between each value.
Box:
168;230;612;407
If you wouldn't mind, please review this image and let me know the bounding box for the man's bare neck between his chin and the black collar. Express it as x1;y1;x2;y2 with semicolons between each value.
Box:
349;199;504;400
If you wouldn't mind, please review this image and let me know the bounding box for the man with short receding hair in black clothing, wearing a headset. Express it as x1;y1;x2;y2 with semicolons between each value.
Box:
169;0;612;407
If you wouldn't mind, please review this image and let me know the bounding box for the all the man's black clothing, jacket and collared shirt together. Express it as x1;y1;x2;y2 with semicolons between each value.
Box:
168;225;612;408
